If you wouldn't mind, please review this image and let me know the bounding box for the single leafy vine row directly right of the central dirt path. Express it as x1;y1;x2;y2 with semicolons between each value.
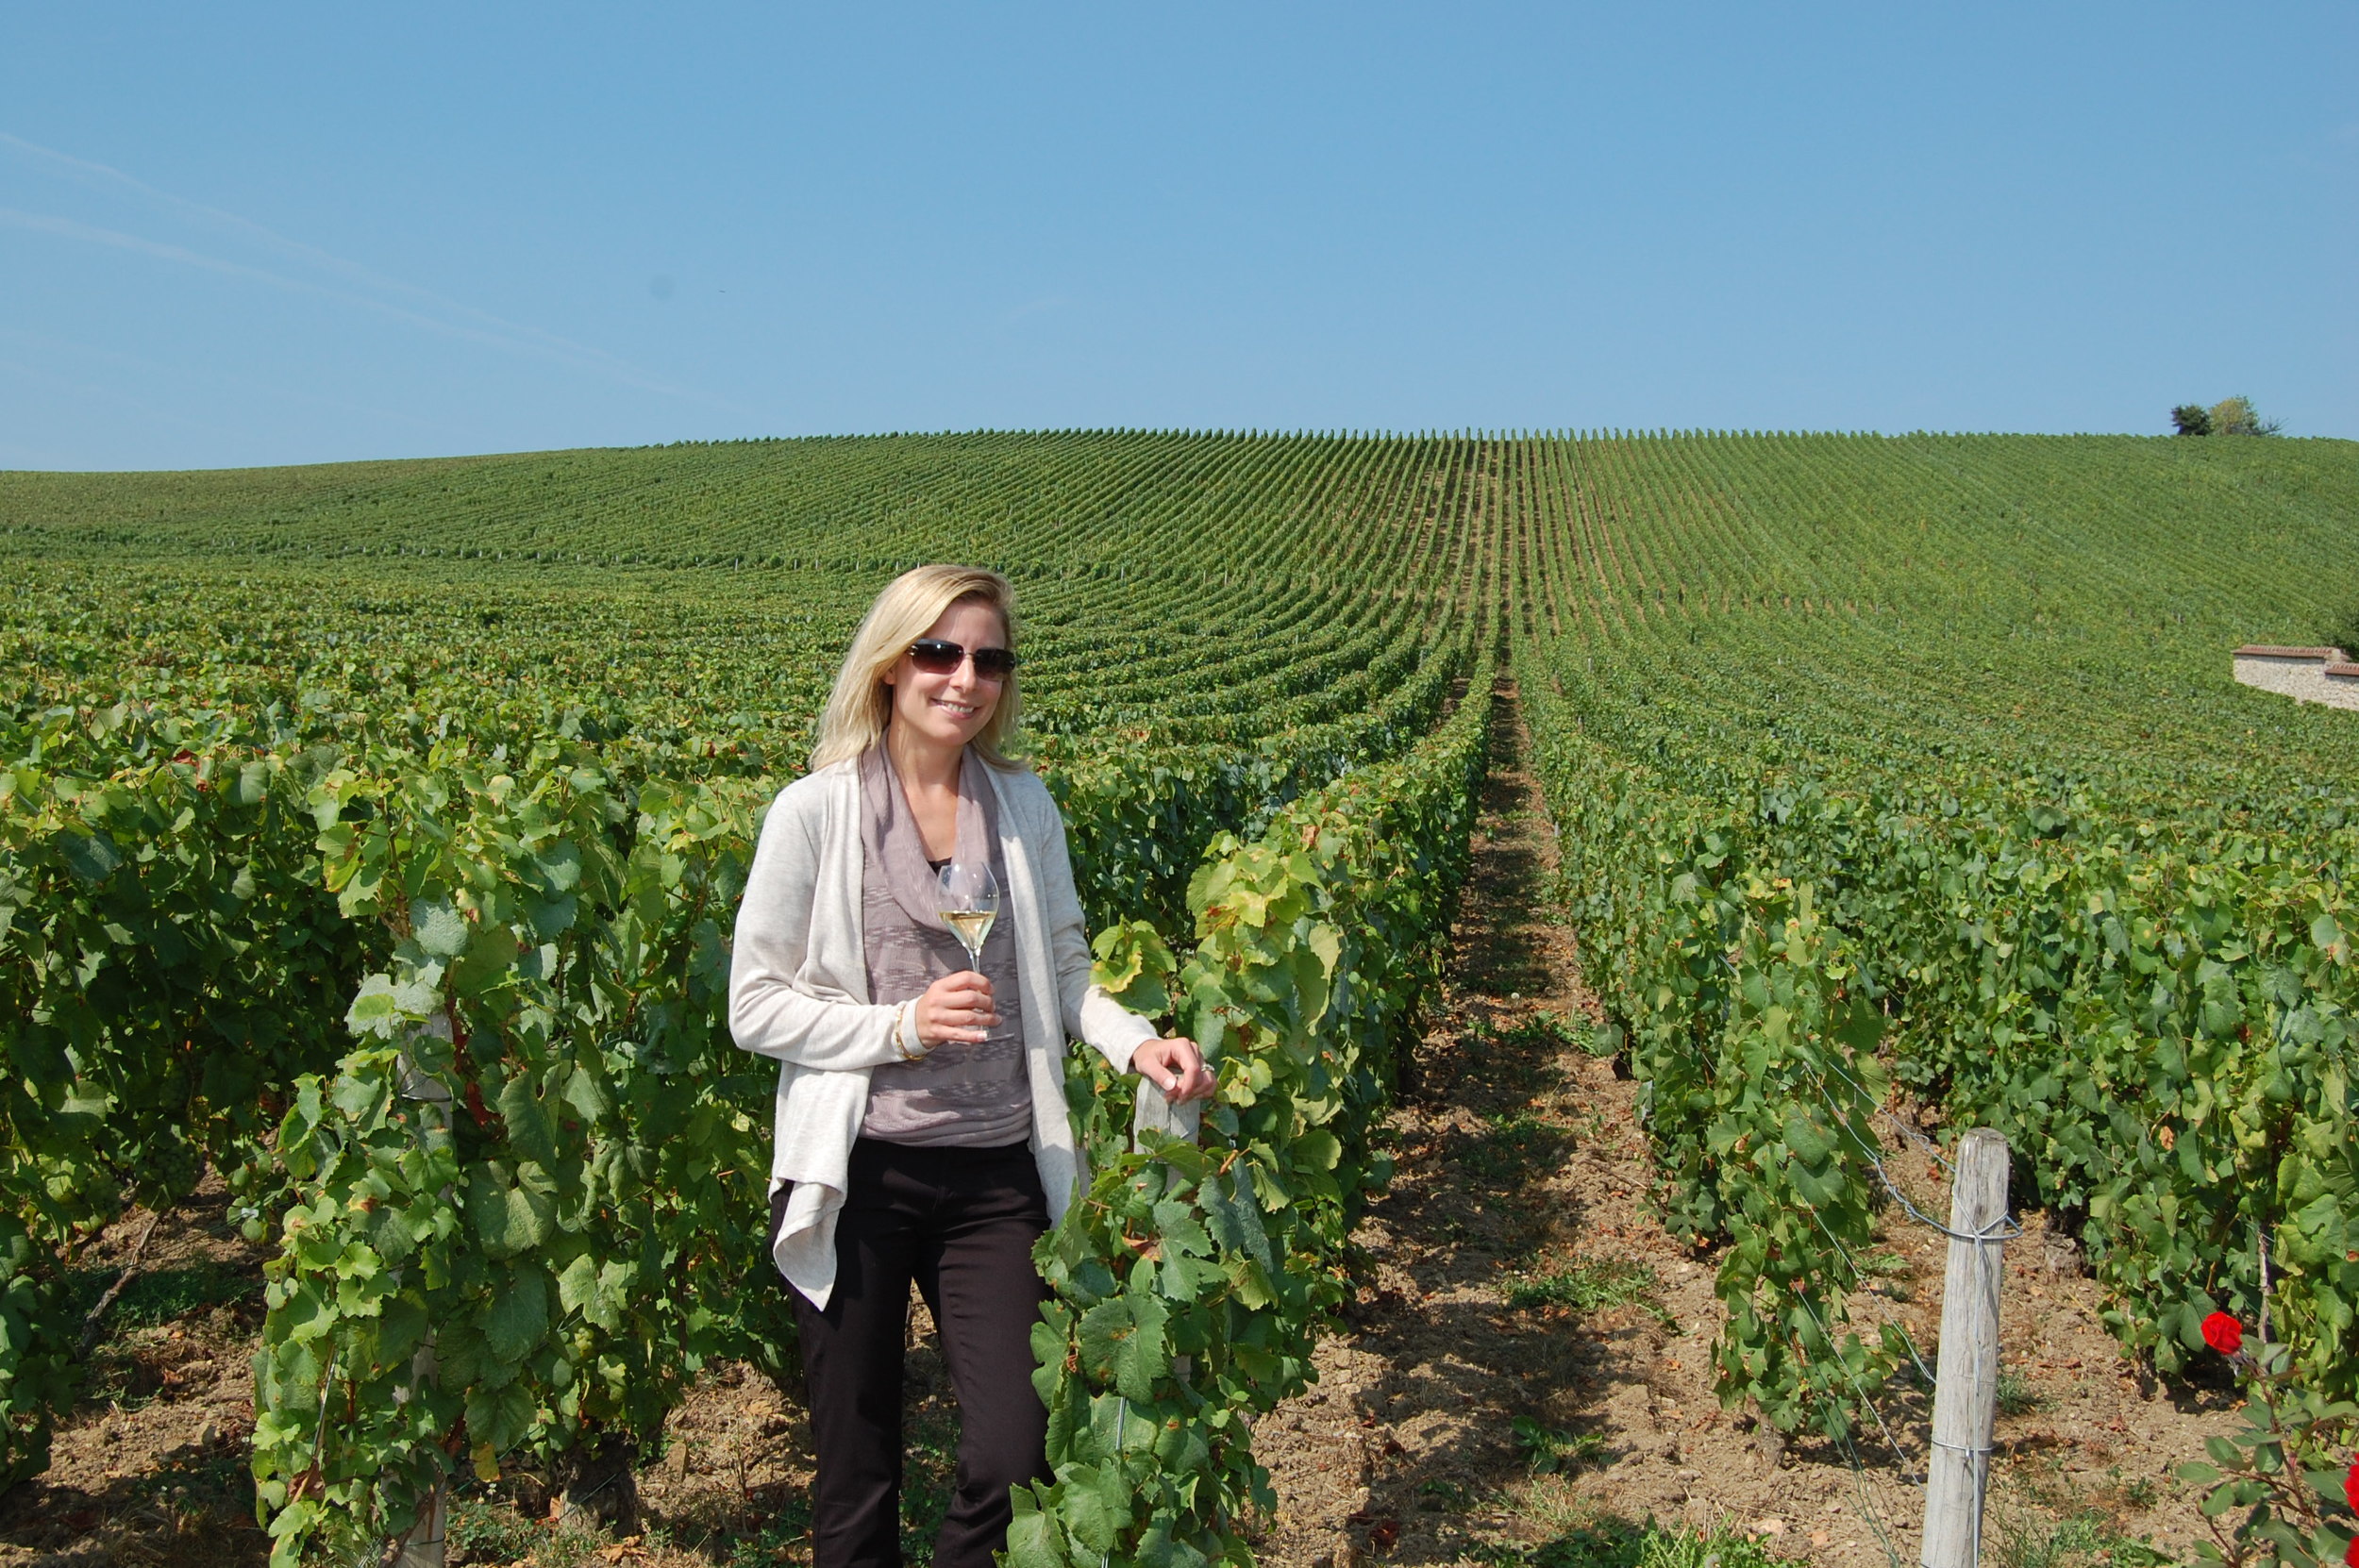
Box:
1522;675;1901;1434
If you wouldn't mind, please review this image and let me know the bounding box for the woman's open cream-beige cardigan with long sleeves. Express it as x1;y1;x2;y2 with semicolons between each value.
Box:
729;761;1156;1307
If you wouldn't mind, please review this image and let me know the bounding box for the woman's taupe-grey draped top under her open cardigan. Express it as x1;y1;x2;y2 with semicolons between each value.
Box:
862;745;1033;1148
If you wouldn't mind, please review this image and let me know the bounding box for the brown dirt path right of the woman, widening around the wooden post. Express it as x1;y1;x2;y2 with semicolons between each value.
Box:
1255;691;2234;1568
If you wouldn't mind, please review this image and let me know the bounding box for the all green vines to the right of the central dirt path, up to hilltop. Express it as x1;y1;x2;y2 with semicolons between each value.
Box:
1519;428;2359;1420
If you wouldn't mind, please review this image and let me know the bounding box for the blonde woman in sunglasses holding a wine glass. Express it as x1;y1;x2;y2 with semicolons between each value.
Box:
729;566;1213;1568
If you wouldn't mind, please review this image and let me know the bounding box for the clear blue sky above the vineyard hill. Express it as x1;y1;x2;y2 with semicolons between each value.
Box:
0;0;2359;469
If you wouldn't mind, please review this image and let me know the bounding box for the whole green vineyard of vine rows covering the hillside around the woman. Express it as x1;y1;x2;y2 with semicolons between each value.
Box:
0;431;2359;1568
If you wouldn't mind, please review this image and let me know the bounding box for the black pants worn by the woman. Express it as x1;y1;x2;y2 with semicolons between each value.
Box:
769;1139;1047;1568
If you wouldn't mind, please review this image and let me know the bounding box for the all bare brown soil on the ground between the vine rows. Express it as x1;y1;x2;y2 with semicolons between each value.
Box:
0;692;2234;1568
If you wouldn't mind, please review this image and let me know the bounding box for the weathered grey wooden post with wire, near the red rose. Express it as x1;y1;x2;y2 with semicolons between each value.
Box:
1918;1127;2008;1568
